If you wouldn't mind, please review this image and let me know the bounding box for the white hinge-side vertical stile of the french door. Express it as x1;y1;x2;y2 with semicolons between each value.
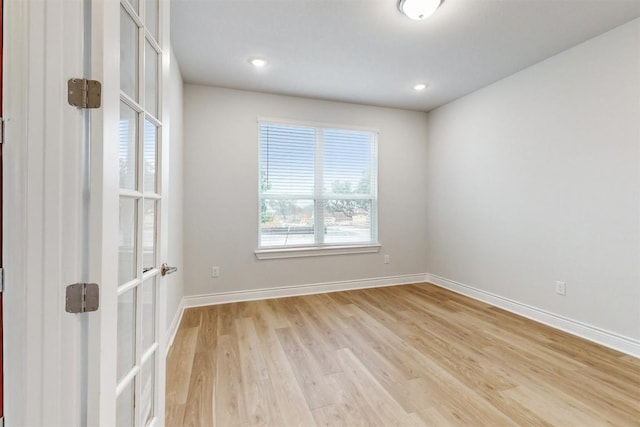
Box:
87;0;120;426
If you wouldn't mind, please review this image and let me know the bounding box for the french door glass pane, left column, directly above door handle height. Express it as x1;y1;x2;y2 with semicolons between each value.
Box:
118;197;137;285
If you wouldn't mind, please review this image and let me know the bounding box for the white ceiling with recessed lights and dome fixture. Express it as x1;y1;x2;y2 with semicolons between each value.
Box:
171;0;640;111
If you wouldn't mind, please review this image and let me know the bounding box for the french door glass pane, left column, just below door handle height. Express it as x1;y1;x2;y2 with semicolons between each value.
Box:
117;288;136;382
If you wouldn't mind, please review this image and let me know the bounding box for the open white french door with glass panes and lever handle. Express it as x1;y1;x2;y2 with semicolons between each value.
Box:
89;0;168;427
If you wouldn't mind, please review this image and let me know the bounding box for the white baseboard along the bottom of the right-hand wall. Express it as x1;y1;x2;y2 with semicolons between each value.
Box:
426;274;640;357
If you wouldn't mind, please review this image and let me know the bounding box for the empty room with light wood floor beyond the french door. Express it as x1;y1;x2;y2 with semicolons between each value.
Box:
166;0;640;426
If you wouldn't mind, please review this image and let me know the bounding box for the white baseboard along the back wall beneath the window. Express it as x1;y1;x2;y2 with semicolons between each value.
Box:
183;273;425;308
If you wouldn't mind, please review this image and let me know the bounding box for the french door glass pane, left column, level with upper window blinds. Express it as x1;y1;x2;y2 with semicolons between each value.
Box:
119;102;138;190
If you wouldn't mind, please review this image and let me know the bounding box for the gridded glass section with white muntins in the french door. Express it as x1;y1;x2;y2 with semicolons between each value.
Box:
116;0;162;427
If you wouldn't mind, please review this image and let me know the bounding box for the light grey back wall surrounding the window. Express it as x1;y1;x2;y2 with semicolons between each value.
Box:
184;84;427;295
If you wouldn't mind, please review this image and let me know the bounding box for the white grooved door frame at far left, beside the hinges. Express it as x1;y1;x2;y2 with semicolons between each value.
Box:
3;0;88;427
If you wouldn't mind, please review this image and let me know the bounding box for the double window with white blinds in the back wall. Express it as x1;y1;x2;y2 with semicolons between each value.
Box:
258;118;378;256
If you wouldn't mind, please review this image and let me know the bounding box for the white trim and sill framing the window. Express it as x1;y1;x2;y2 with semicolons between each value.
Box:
254;116;381;260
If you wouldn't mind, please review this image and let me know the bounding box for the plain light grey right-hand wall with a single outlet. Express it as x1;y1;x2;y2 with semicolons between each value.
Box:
424;19;640;340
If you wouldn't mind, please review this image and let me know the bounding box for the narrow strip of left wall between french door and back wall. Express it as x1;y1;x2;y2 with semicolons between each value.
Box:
165;50;184;327
